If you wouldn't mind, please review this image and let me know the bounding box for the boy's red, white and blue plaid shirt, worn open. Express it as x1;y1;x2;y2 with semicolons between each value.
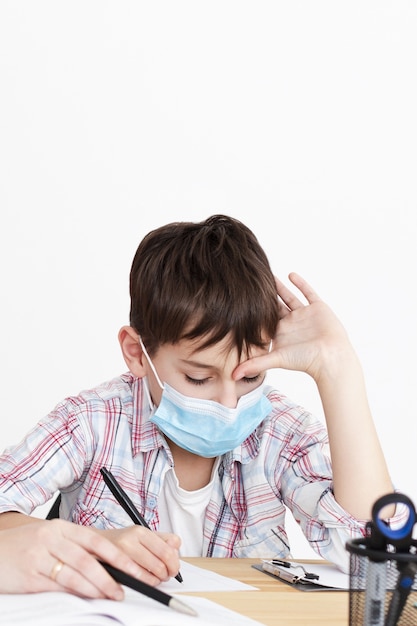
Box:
0;373;364;569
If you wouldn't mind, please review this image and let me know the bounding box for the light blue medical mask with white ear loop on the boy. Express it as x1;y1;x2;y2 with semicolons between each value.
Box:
140;340;272;458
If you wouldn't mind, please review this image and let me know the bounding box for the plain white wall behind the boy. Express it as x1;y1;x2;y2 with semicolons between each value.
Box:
0;0;417;556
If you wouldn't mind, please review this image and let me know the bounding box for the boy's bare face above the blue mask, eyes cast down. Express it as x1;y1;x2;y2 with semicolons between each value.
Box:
143;337;267;408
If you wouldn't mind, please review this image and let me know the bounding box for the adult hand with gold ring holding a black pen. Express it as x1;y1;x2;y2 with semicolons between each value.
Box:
0;519;142;600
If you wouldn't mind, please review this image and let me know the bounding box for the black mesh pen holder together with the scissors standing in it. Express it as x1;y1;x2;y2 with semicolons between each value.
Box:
346;493;417;626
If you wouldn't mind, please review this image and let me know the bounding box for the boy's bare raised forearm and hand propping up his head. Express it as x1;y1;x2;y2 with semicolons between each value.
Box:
234;274;393;520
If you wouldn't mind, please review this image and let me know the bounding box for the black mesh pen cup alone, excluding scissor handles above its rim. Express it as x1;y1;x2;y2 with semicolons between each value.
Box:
346;538;417;626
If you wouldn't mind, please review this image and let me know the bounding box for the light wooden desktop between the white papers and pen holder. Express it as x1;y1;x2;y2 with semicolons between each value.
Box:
184;558;349;626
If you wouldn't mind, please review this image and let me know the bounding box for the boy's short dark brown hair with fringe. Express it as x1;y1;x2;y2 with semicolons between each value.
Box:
130;215;278;356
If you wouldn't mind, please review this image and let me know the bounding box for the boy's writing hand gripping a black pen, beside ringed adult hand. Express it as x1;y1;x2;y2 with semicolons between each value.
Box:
95;525;181;585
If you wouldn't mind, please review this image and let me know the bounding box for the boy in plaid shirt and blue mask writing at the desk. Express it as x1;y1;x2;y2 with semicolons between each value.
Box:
0;215;392;588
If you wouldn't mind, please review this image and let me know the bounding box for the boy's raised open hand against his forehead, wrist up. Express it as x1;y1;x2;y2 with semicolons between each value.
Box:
233;273;352;383
